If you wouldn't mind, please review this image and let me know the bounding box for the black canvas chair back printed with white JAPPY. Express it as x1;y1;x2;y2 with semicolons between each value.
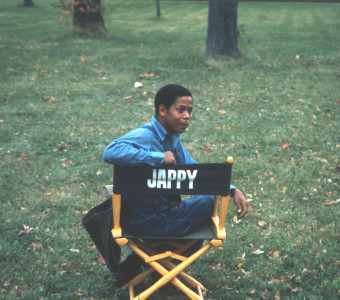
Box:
113;163;232;196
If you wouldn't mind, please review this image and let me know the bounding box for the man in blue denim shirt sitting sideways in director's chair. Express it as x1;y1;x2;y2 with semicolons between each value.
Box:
104;84;247;284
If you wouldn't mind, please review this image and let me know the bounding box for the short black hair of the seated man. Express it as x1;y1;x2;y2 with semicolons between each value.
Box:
155;84;192;115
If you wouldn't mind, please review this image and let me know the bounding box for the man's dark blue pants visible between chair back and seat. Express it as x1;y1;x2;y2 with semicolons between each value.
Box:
122;194;214;237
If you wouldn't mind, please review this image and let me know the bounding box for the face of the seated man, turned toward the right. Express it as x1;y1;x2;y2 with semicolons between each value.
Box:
159;96;193;135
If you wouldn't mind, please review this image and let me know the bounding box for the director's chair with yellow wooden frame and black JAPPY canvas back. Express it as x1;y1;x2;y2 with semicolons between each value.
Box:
106;157;233;299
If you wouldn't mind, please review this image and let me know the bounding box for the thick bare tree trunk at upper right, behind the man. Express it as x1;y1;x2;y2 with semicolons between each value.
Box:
205;1;240;56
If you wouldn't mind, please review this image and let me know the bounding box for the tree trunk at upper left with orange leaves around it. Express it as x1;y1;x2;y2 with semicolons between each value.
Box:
73;0;107;36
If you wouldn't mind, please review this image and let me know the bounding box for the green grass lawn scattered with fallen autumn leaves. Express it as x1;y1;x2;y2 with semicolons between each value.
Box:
0;0;340;299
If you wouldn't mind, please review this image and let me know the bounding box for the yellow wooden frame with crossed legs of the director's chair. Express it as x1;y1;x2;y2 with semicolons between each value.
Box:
107;157;233;300
